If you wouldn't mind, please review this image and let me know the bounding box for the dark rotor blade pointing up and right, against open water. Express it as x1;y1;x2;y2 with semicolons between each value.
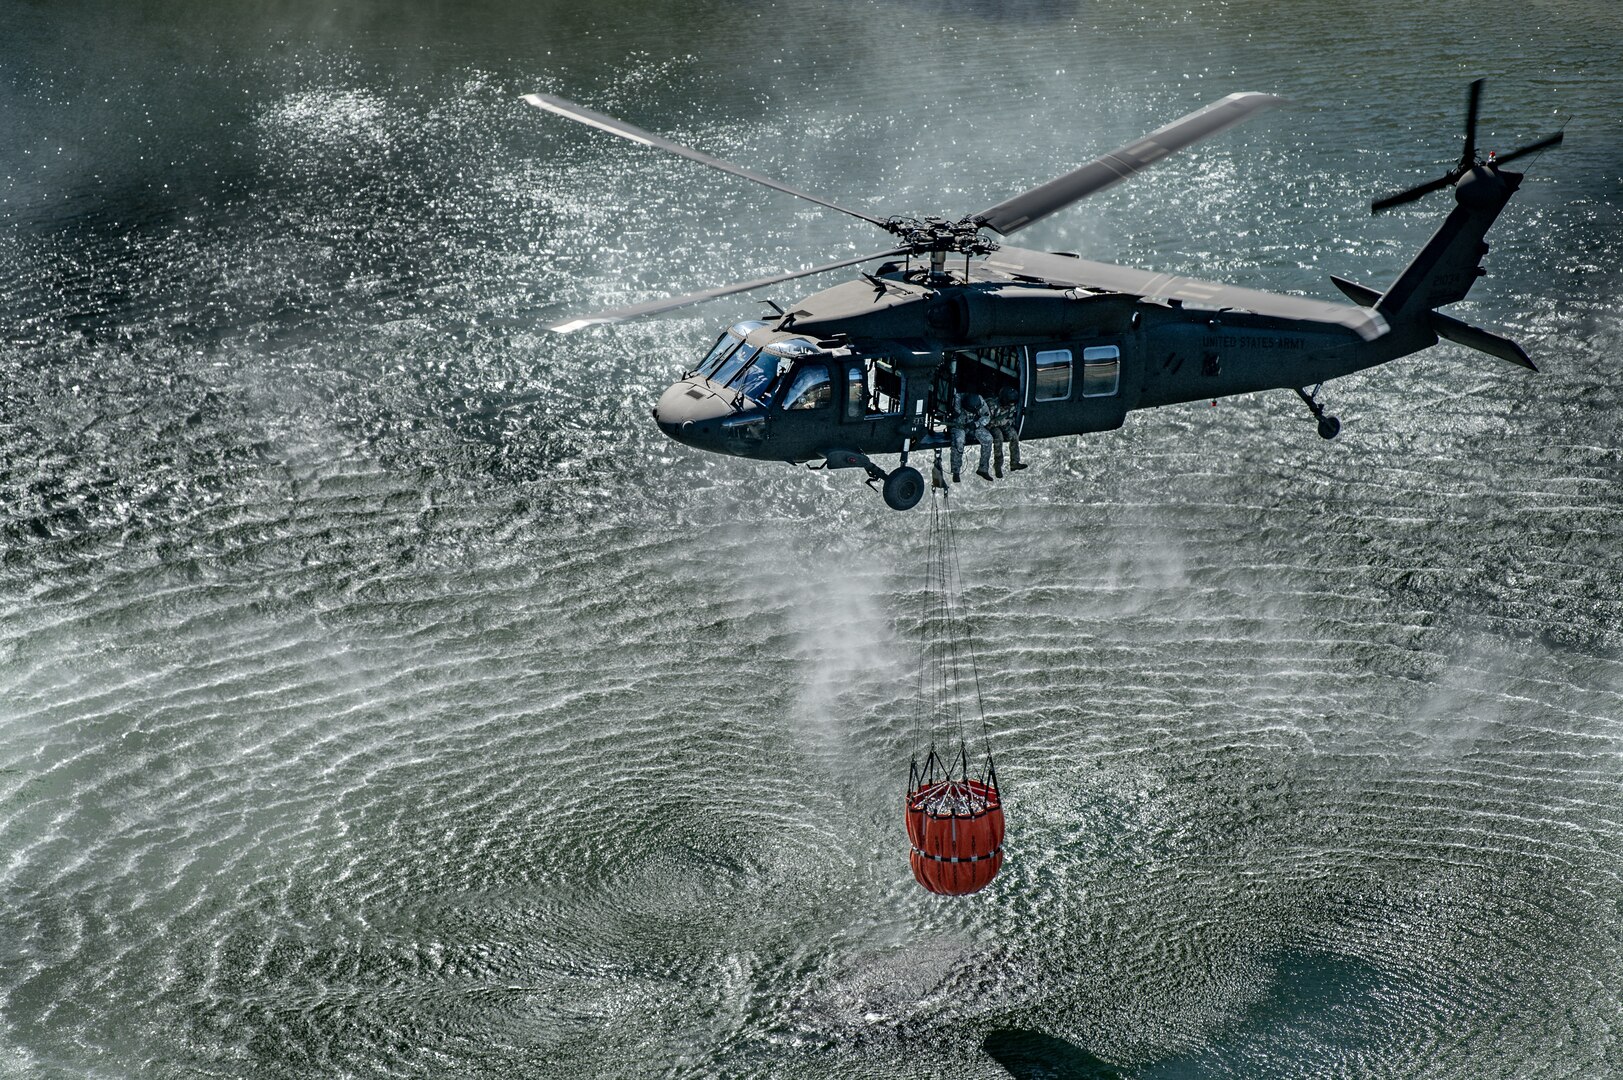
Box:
974;94;1285;235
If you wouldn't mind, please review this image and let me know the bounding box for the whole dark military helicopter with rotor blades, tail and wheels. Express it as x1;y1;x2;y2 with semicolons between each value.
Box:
524;80;1561;510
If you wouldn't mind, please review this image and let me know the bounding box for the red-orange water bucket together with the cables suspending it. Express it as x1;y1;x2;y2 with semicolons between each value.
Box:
906;477;1003;896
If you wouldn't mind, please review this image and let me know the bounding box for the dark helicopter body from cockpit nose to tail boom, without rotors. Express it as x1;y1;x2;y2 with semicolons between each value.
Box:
654;253;1436;468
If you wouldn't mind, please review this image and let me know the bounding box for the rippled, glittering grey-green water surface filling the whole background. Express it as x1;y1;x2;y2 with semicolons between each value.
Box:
0;0;1623;1080
